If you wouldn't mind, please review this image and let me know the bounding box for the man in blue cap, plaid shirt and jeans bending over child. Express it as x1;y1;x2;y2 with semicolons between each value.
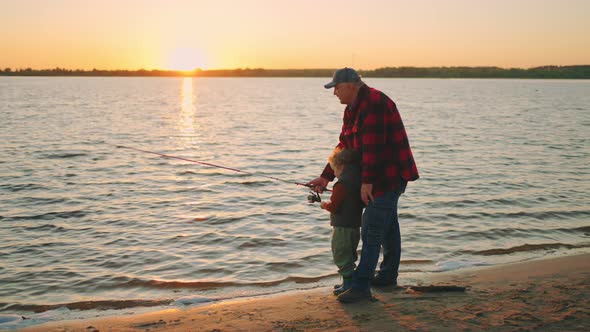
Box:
308;68;419;303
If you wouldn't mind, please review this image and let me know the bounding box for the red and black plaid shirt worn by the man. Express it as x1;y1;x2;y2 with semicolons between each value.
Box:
322;85;419;197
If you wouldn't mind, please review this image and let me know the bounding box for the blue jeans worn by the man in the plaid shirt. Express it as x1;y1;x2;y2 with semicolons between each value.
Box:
352;190;402;290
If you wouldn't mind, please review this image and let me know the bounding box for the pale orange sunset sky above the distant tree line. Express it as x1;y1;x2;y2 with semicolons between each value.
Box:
0;0;590;70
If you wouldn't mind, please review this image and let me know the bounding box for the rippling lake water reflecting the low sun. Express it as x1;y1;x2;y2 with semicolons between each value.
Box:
0;77;590;321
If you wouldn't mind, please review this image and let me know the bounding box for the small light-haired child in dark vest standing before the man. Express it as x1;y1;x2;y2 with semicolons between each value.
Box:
320;149;364;295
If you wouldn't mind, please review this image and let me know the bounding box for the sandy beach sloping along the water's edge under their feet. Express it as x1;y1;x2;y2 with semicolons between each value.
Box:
16;254;590;332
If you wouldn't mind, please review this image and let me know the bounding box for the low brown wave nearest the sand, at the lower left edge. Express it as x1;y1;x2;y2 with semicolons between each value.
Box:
1;299;174;313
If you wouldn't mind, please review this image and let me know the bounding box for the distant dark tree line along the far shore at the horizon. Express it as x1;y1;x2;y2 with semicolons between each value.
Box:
0;65;590;79
